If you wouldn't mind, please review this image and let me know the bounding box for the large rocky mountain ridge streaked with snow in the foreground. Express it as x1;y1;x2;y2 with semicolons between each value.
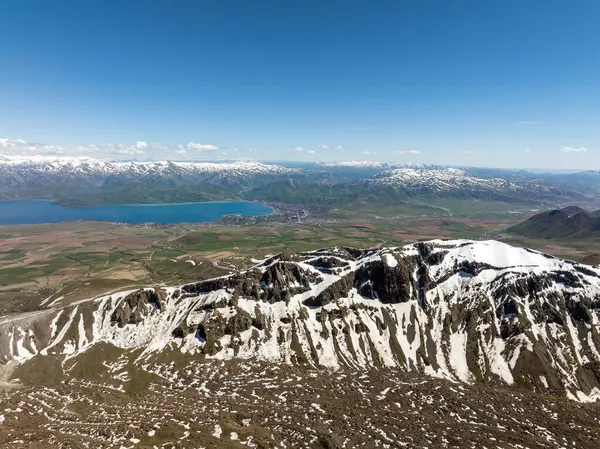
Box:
0;240;600;400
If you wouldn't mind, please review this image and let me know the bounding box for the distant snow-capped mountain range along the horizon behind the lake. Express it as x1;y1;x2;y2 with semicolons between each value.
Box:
0;156;596;205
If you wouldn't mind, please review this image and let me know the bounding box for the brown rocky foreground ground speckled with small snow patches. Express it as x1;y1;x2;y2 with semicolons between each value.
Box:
0;356;600;449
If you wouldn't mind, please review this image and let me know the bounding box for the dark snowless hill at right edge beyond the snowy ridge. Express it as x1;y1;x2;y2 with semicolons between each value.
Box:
508;206;600;239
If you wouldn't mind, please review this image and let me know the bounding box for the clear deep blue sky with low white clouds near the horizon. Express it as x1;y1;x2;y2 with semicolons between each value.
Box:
0;0;600;169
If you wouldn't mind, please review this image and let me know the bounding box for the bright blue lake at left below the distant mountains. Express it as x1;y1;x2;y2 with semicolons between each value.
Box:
0;200;272;225
